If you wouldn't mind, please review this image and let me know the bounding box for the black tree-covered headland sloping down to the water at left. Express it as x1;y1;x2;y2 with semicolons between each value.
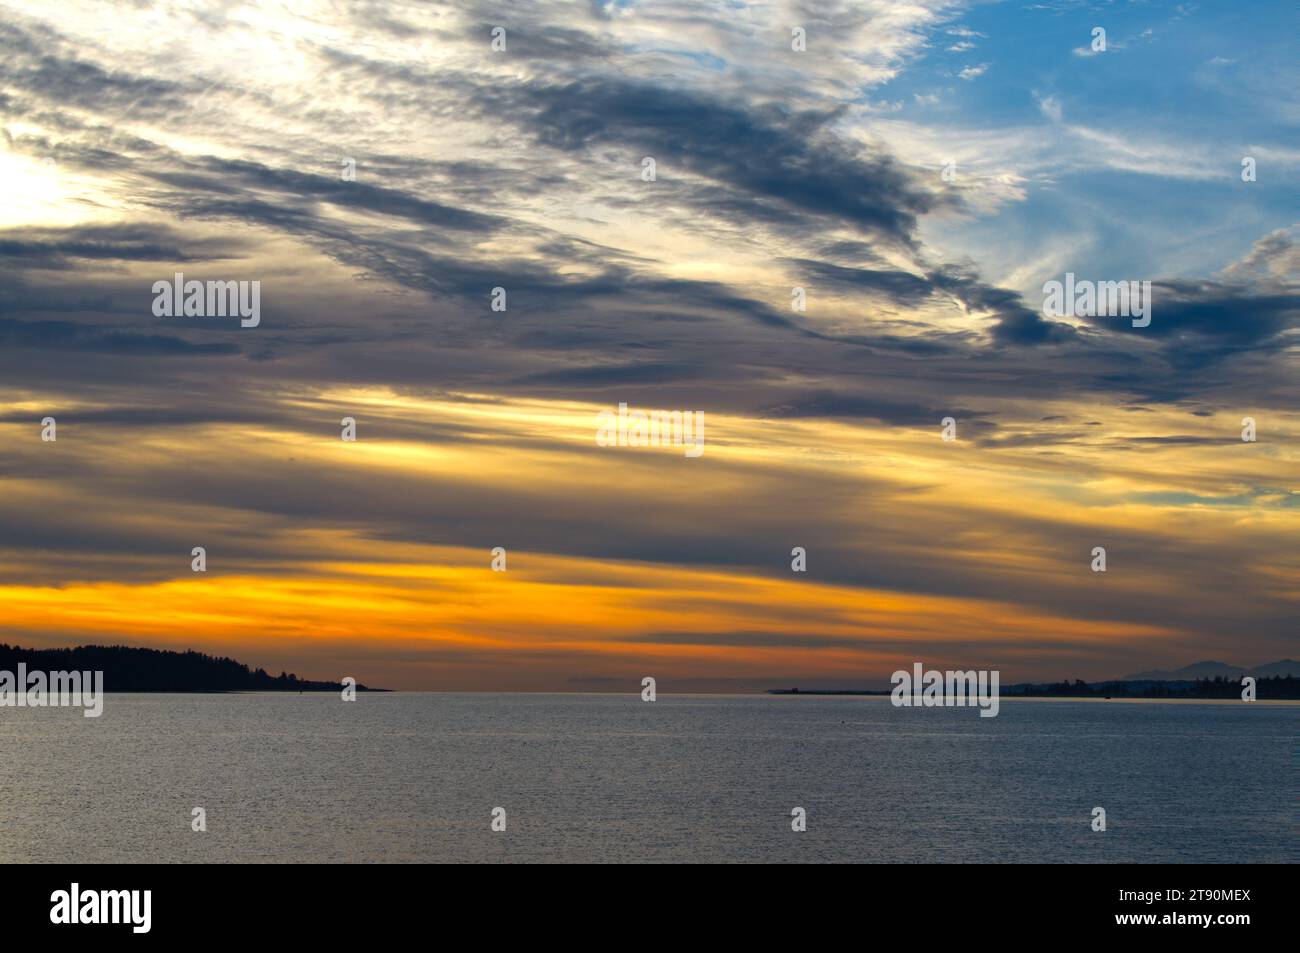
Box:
0;645;382;692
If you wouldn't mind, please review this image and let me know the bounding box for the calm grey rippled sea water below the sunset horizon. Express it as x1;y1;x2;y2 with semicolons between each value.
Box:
0;693;1300;863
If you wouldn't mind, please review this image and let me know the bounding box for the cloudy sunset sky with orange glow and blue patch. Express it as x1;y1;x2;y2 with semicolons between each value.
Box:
0;0;1300;692
